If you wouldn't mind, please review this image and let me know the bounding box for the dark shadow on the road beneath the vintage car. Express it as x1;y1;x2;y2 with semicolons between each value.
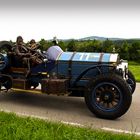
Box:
0;92;93;116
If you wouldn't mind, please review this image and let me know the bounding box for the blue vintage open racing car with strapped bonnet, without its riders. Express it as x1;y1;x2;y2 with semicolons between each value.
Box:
0;42;136;119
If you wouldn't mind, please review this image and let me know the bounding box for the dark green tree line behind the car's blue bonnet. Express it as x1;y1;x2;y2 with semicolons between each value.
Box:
39;39;140;62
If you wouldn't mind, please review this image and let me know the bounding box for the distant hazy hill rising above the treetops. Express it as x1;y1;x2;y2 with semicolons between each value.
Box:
79;36;124;41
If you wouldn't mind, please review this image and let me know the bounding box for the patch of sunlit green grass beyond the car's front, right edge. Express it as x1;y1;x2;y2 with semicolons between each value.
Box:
129;61;140;82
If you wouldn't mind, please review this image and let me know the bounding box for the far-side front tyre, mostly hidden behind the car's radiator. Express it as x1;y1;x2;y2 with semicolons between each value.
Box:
127;70;136;94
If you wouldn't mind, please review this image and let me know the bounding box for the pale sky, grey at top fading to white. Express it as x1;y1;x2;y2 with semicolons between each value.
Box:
0;0;140;41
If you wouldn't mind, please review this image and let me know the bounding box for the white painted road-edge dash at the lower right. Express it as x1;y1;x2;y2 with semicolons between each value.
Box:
101;127;140;135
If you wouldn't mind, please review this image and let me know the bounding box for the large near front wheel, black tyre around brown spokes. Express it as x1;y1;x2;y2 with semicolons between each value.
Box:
85;74;132;119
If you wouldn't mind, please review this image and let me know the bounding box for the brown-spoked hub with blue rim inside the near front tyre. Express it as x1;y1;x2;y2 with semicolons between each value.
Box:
92;82;122;111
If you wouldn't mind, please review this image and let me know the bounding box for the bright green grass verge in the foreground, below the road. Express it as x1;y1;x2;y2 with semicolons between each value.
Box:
0;112;140;140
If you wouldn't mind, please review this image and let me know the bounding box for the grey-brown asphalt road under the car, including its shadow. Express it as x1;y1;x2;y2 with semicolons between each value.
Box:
0;83;140;134
